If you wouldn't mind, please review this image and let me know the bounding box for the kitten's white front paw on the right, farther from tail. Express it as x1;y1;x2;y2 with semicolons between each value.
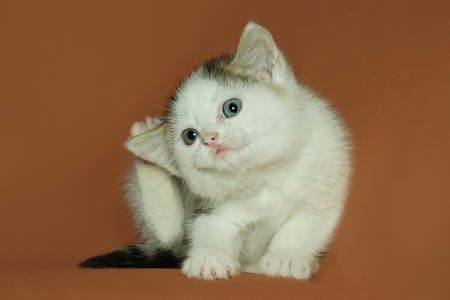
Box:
259;251;319;280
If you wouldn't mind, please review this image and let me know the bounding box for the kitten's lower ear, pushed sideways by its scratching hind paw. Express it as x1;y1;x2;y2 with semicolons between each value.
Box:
125;123;178;175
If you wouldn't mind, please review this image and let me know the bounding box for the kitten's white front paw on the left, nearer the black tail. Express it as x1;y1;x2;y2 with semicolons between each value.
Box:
181;251;241;280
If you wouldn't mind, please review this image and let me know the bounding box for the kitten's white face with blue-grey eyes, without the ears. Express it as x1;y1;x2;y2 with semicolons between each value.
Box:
171;73;289;176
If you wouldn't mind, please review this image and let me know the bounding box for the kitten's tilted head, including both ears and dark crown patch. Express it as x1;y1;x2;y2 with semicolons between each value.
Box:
127;23;299;179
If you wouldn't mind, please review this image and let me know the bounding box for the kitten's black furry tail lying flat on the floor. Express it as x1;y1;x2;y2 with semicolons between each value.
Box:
79;245;183;269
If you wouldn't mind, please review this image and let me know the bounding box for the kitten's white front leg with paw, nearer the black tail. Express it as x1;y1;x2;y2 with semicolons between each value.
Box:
182;203;260;280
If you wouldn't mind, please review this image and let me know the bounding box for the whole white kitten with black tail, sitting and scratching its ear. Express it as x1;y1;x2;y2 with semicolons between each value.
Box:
81;22;351;280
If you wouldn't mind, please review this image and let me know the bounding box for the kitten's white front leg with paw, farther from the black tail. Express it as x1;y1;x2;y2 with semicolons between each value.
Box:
259;209;340;280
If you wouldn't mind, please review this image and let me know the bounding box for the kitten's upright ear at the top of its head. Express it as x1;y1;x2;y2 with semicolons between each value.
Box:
231;22;281;82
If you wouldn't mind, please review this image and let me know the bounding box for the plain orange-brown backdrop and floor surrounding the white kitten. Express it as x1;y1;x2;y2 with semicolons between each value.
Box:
0;0;450;299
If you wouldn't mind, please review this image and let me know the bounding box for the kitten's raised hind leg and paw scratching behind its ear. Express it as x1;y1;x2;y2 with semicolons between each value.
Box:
128;117;184;248
